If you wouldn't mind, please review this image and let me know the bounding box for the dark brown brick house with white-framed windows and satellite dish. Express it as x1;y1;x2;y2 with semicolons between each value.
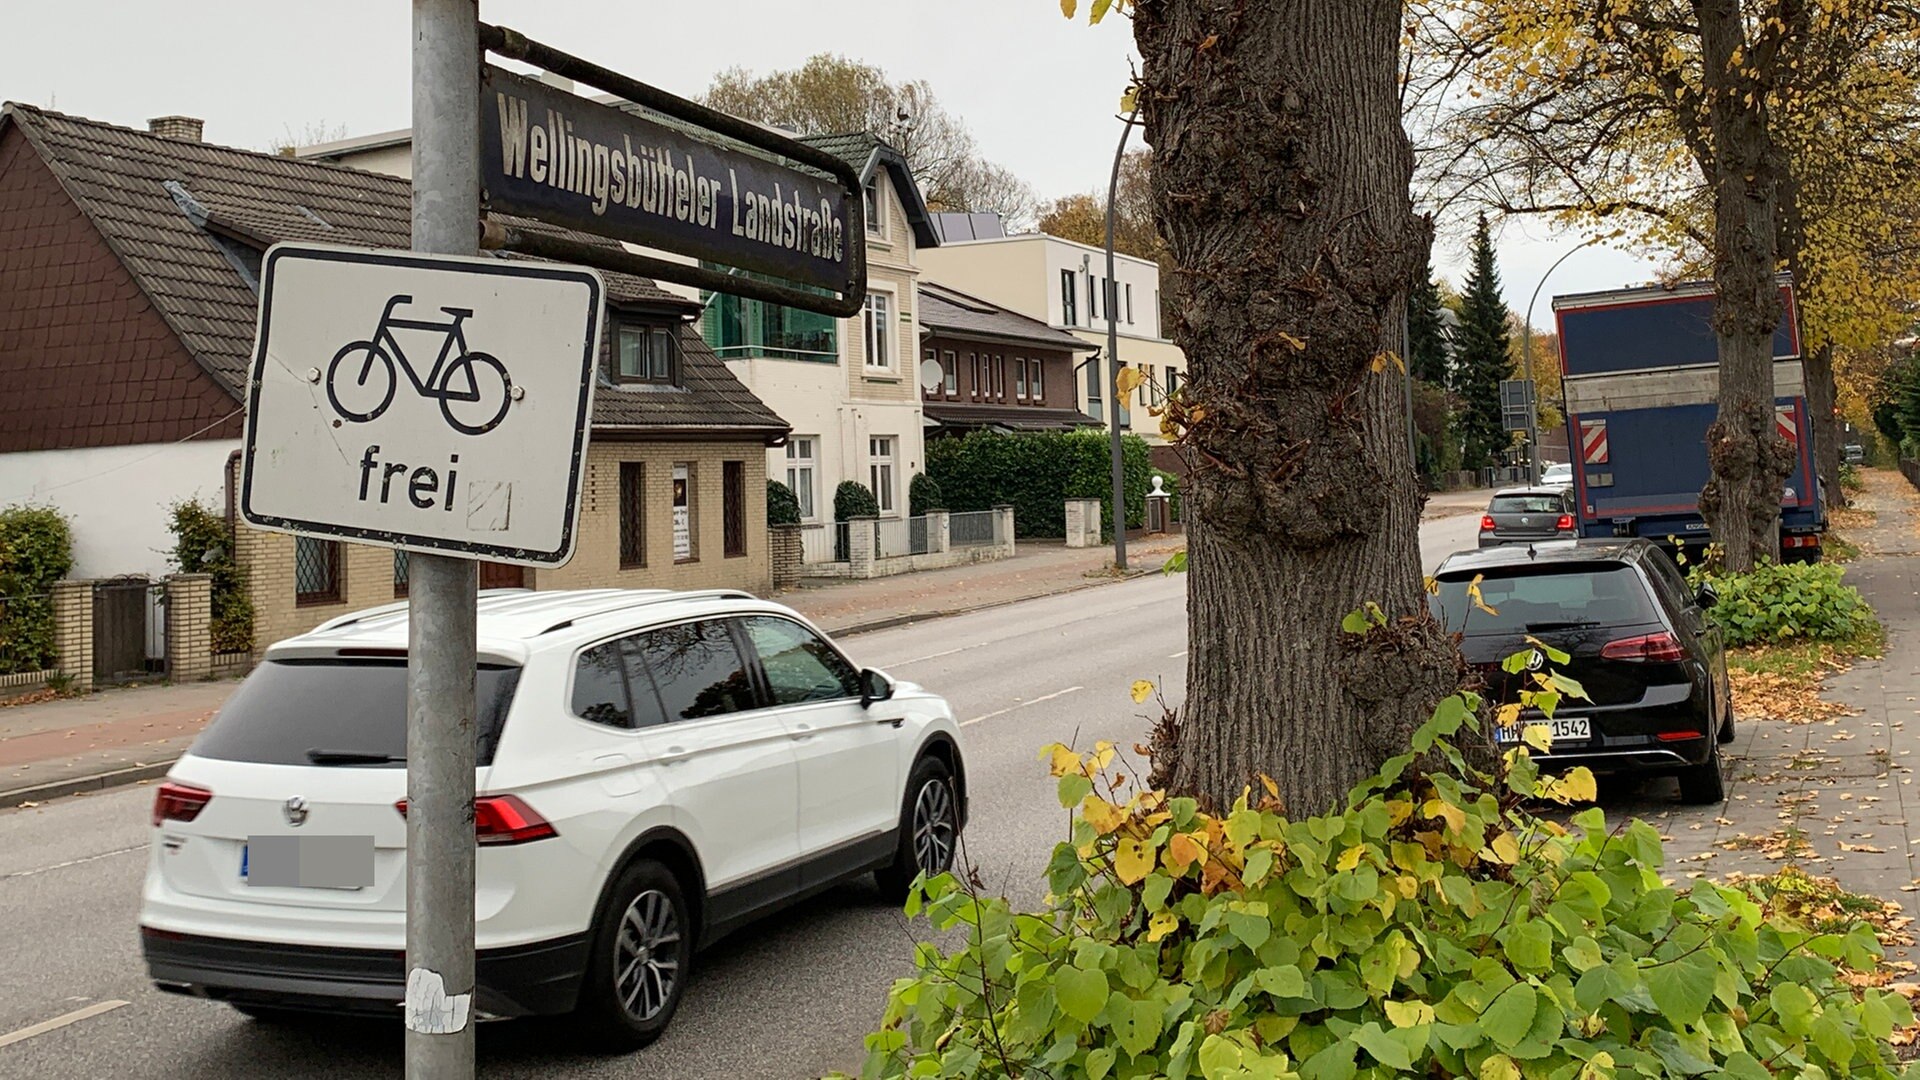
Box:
920;281;1100;438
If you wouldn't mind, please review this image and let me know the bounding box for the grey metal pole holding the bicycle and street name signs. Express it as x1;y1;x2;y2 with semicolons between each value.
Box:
407;0;480;1080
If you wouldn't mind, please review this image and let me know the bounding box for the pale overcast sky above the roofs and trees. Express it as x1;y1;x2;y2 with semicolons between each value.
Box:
0;0;1655;327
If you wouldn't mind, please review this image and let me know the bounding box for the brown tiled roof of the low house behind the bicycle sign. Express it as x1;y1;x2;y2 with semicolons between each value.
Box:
0;104;787;434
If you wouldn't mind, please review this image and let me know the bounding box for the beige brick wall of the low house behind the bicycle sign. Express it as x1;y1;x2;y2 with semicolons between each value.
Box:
234;432;772;651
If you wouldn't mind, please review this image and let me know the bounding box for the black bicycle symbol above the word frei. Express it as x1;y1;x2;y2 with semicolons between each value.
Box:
326;294;513;434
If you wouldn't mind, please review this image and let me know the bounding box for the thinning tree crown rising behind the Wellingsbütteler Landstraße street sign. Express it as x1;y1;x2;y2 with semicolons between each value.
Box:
701;52;1039;227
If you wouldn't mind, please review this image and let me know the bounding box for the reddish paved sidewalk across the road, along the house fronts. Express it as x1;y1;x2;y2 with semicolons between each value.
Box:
0;536;1185;809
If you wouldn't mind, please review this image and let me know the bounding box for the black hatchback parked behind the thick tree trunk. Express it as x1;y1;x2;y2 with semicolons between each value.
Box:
1428;540;1734;803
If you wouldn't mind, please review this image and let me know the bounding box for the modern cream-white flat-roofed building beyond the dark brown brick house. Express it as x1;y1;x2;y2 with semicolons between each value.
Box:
920;233;1187;442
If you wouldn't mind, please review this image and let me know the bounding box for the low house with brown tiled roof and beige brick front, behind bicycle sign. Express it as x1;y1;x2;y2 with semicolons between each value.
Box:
0;104;787;646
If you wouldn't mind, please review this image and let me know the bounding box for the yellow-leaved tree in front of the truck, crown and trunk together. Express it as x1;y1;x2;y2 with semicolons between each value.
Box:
1413;0;1914;569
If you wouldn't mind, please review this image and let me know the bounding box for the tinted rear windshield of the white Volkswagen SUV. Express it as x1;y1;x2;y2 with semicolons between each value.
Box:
192;659;520;769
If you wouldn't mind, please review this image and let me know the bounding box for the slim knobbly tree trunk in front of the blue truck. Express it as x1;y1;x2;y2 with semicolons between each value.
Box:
1693;0;1793;571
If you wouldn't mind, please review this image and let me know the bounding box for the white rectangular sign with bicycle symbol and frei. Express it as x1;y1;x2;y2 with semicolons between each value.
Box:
240;244;603;567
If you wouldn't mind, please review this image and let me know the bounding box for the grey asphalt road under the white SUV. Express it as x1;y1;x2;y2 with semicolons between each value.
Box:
0;515;1476;1080
